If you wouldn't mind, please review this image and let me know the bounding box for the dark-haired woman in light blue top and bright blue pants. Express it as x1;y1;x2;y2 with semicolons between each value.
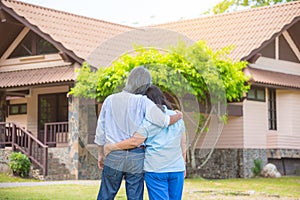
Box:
104;86;186;200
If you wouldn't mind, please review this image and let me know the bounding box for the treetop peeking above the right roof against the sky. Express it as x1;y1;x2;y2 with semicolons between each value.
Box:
205;0;294;14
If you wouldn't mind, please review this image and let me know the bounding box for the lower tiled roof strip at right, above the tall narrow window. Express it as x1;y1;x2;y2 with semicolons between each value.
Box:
244;67;300;88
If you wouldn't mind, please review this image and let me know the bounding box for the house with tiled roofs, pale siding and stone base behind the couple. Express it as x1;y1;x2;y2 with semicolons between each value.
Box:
0;0;300;179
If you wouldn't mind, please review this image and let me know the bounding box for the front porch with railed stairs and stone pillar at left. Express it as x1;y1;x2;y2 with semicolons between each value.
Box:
0;97;101;180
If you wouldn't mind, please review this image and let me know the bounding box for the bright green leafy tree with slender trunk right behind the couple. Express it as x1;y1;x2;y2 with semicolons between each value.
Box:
70;41;249;173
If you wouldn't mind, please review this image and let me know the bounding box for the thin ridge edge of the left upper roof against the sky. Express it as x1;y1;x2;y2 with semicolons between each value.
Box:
1;0;135;28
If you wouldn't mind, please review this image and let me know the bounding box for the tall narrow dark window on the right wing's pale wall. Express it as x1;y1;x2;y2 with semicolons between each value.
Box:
268;88;277;130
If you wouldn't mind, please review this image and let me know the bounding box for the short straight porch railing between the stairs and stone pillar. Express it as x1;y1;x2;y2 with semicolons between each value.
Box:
44;122;69;147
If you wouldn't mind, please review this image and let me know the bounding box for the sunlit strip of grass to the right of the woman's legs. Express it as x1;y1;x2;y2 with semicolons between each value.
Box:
185;177;300;199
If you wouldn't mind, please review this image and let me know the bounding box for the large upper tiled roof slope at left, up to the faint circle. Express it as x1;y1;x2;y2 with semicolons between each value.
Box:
1;0;133;59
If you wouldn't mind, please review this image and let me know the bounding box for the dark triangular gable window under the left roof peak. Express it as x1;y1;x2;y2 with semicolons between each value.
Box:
9;32;58;58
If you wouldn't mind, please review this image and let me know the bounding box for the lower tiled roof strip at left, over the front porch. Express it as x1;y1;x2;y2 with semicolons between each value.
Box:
0;66;75;88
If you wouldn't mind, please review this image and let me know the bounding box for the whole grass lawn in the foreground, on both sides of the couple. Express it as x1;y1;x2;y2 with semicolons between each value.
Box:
0;174;300;200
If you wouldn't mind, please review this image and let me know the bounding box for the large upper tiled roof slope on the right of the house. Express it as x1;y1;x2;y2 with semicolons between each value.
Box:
155;1;300;59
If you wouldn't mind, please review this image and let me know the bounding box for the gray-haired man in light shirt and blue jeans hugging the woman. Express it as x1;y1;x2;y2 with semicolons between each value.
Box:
95;66;182;200
